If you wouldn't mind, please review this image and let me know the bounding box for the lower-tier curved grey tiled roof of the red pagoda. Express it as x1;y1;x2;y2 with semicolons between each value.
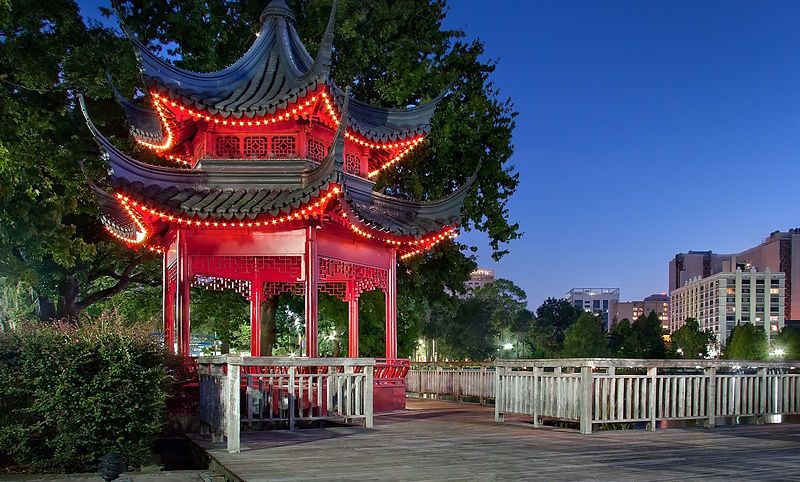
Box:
79;92;475;237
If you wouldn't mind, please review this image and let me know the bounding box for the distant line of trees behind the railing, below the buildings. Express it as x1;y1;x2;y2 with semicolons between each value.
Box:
424;290;800;360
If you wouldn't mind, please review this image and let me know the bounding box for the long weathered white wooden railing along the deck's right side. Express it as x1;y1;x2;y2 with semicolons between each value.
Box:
494;359;800;434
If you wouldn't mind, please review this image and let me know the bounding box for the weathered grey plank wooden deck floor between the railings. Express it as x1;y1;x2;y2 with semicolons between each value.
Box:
195;399;800;481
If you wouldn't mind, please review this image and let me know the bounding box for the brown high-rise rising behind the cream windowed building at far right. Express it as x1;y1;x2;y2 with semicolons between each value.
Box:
668;229;800;321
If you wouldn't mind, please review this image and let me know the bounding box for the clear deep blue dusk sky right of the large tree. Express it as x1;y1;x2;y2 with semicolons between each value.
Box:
79;0;800;309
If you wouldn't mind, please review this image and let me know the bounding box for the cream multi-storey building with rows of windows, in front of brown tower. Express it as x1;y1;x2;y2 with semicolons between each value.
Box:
670;268;786;344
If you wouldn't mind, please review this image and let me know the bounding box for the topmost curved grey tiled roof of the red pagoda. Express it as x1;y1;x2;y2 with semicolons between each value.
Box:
120;0;450;142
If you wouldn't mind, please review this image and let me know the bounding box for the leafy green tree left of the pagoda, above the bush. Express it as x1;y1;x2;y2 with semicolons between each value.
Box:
0;0;160;320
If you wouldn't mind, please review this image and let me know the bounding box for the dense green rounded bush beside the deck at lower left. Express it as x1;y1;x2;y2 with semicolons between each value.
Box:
0;319;169;472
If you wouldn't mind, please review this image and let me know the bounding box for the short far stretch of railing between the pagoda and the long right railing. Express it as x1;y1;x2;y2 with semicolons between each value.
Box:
406;362;495;403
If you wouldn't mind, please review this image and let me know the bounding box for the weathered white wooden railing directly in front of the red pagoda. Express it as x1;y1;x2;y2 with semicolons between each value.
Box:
197;356;375;453
